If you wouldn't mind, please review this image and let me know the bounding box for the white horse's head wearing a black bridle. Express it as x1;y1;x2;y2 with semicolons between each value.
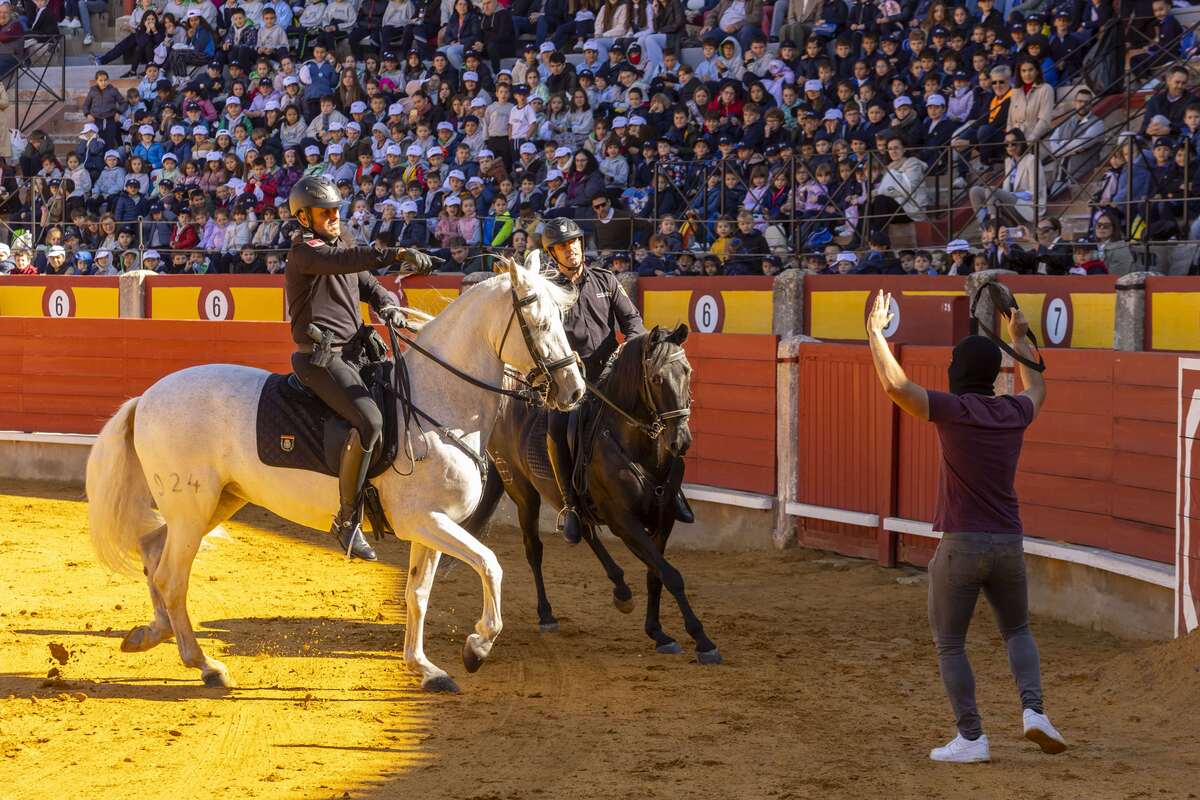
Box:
499;251;586;411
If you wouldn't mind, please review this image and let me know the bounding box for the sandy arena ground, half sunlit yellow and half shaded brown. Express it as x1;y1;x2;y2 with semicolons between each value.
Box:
0;483;1200;800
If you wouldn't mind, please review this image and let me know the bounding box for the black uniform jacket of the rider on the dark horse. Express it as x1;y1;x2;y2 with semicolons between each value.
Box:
558;266;646;381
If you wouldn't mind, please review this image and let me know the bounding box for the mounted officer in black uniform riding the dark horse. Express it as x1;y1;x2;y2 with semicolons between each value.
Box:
541;217;691;545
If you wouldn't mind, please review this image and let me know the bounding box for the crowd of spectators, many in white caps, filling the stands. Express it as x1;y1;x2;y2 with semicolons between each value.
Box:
0;0;1200;275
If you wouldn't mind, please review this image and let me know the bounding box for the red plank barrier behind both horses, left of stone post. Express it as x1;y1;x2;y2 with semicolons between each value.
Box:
0;318;776;494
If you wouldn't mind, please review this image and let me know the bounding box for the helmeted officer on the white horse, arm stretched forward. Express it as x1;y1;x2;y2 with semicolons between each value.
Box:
286;175;433;561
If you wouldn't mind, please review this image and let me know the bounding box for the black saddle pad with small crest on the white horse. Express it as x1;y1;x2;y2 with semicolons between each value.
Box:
254;362;398;477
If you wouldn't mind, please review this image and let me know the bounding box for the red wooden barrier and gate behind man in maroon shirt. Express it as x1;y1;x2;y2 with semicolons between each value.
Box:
797;344;1178;565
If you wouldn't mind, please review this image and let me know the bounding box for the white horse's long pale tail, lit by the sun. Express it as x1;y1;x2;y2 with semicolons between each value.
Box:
86;397;162;575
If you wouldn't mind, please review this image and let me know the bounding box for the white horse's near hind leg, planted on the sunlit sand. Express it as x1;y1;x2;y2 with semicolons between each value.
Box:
154;489;234;687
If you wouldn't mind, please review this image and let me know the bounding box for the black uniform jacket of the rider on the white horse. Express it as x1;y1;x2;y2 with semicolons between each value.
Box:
284;231;392;345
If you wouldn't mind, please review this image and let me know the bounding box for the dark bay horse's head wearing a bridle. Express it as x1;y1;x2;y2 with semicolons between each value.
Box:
601;323;691;456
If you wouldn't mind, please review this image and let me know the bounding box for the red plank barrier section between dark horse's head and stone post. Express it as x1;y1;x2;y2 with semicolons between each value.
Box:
684;333;778;495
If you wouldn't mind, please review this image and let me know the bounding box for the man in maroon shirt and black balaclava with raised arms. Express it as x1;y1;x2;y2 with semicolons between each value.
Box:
866;291;1067;763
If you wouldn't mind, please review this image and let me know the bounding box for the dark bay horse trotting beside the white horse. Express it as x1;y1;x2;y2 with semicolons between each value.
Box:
463;325;721;663
